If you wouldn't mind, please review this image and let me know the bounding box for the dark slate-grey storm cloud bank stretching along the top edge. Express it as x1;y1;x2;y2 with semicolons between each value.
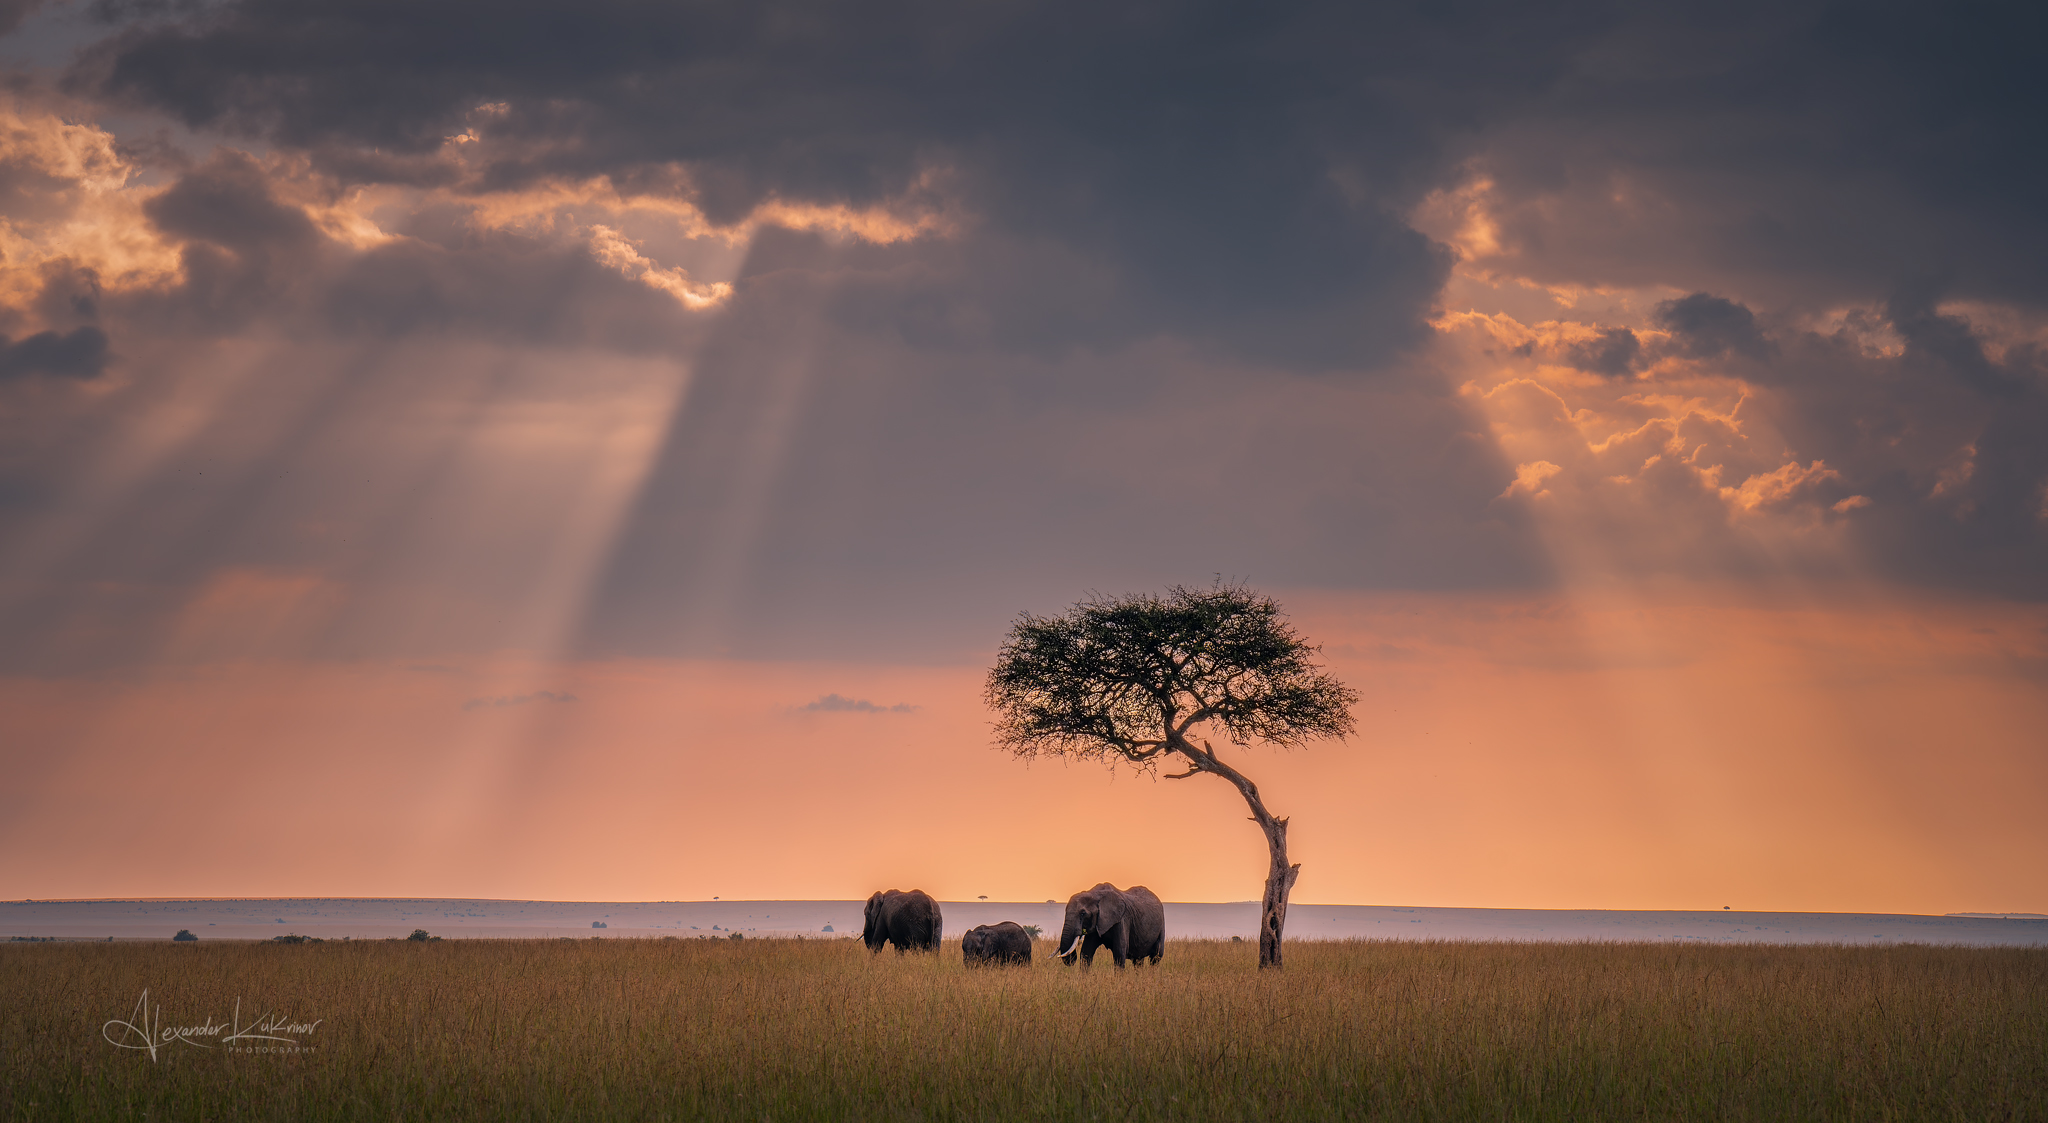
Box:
72;0;2048;354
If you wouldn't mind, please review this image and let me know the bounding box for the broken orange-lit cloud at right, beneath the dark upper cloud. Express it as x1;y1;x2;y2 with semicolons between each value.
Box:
1444;293;2048;596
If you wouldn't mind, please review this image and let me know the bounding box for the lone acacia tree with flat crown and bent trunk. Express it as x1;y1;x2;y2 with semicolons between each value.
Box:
983;582;1358;967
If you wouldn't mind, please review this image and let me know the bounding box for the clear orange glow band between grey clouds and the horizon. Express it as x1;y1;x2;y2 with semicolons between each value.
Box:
0;590;2048;914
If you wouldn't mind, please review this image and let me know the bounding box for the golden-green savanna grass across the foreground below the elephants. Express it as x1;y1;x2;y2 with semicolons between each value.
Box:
0;939;2048;1121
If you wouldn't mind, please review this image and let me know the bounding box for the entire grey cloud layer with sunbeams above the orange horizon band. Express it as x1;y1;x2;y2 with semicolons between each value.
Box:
0;0;2048;909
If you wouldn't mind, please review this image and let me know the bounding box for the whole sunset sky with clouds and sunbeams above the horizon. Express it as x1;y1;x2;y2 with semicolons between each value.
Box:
0;0;2048;912
